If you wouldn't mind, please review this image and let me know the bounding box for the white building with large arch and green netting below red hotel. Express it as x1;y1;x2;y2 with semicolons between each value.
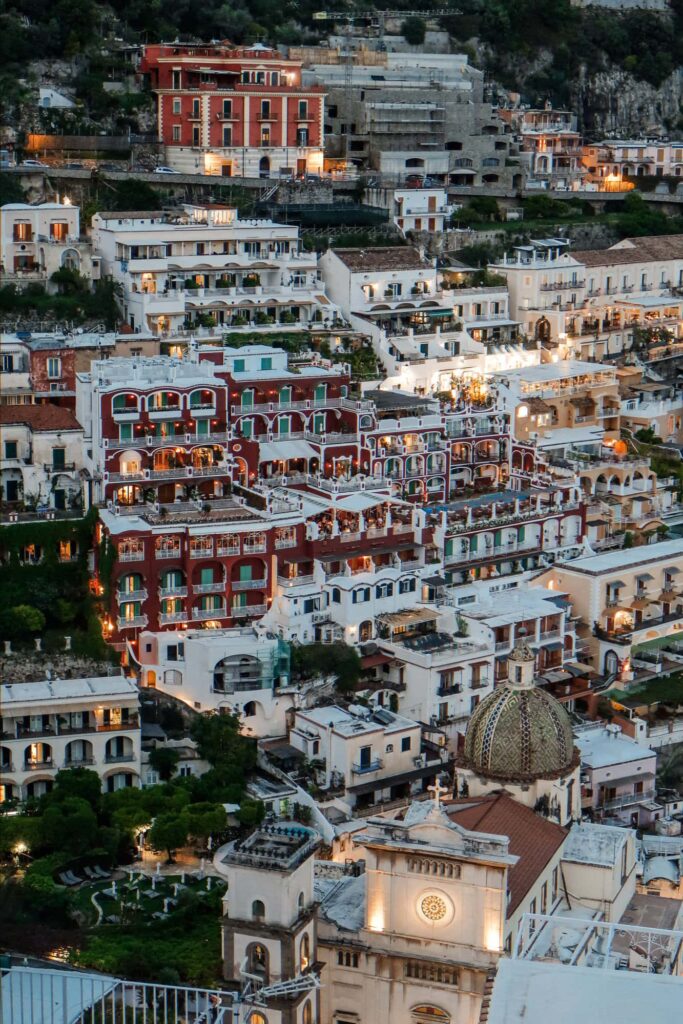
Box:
140;628;296;736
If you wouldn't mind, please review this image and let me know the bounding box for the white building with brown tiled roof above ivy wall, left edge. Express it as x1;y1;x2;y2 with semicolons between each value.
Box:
0;404;90;514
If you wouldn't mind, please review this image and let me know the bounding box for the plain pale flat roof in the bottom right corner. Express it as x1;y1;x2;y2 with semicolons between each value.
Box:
487;957;683;1024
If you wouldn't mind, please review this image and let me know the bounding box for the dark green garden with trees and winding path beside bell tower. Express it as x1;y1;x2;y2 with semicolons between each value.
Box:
0;716;263;985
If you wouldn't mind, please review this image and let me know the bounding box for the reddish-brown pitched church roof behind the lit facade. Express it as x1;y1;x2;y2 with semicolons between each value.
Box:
449;794;568;918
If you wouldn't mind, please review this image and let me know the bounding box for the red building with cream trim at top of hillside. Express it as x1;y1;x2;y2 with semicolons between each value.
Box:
140;43;325;177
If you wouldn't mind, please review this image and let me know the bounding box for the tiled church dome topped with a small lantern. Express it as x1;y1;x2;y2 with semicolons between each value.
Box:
463;641;577;781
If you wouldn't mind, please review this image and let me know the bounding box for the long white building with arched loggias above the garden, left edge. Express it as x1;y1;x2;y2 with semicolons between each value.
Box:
0;676;140;802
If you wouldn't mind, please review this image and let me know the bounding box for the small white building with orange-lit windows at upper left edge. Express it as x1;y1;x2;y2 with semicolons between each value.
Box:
0;203;99;291
